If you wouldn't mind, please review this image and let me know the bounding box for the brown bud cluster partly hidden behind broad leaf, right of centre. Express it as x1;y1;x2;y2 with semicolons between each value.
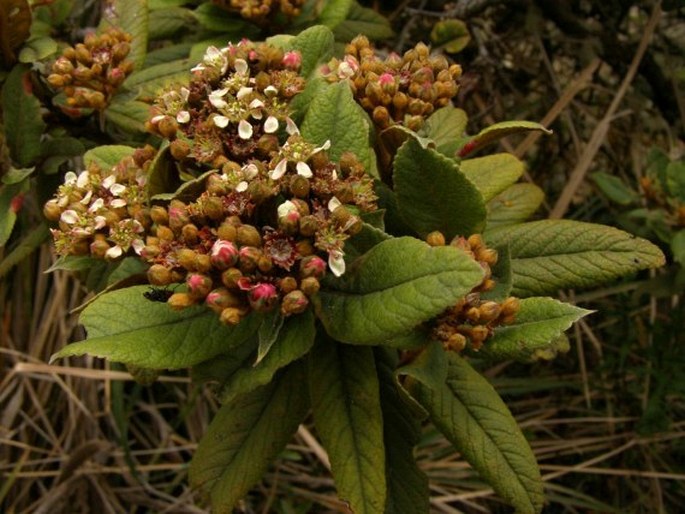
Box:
427;232;520;352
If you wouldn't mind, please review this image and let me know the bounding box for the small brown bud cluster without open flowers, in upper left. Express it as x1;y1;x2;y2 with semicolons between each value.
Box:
48;28;133;111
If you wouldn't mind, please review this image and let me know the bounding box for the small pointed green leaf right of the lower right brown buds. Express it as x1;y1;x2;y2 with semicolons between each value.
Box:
478;297;592;361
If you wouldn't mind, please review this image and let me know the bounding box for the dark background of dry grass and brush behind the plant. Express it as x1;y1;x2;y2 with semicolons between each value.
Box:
0;0;685;513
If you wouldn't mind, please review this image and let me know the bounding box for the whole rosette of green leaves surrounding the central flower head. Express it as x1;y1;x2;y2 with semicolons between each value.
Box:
49;27;663;514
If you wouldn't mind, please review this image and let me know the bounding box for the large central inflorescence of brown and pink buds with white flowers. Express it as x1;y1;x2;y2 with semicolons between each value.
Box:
46;41;376;324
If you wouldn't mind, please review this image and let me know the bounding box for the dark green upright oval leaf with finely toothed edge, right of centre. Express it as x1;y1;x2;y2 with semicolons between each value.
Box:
393;139;485;241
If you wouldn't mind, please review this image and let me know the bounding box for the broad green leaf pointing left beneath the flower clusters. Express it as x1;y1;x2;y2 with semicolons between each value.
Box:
52;286;261;369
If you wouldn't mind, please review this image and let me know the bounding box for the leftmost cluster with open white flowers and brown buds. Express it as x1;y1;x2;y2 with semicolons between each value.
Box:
43;146;156;259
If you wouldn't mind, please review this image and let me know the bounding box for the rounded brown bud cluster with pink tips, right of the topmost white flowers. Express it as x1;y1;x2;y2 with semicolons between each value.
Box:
324;36;461;130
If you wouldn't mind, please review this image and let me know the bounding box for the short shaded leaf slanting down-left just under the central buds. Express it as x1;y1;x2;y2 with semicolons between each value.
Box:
218;310;316;403
